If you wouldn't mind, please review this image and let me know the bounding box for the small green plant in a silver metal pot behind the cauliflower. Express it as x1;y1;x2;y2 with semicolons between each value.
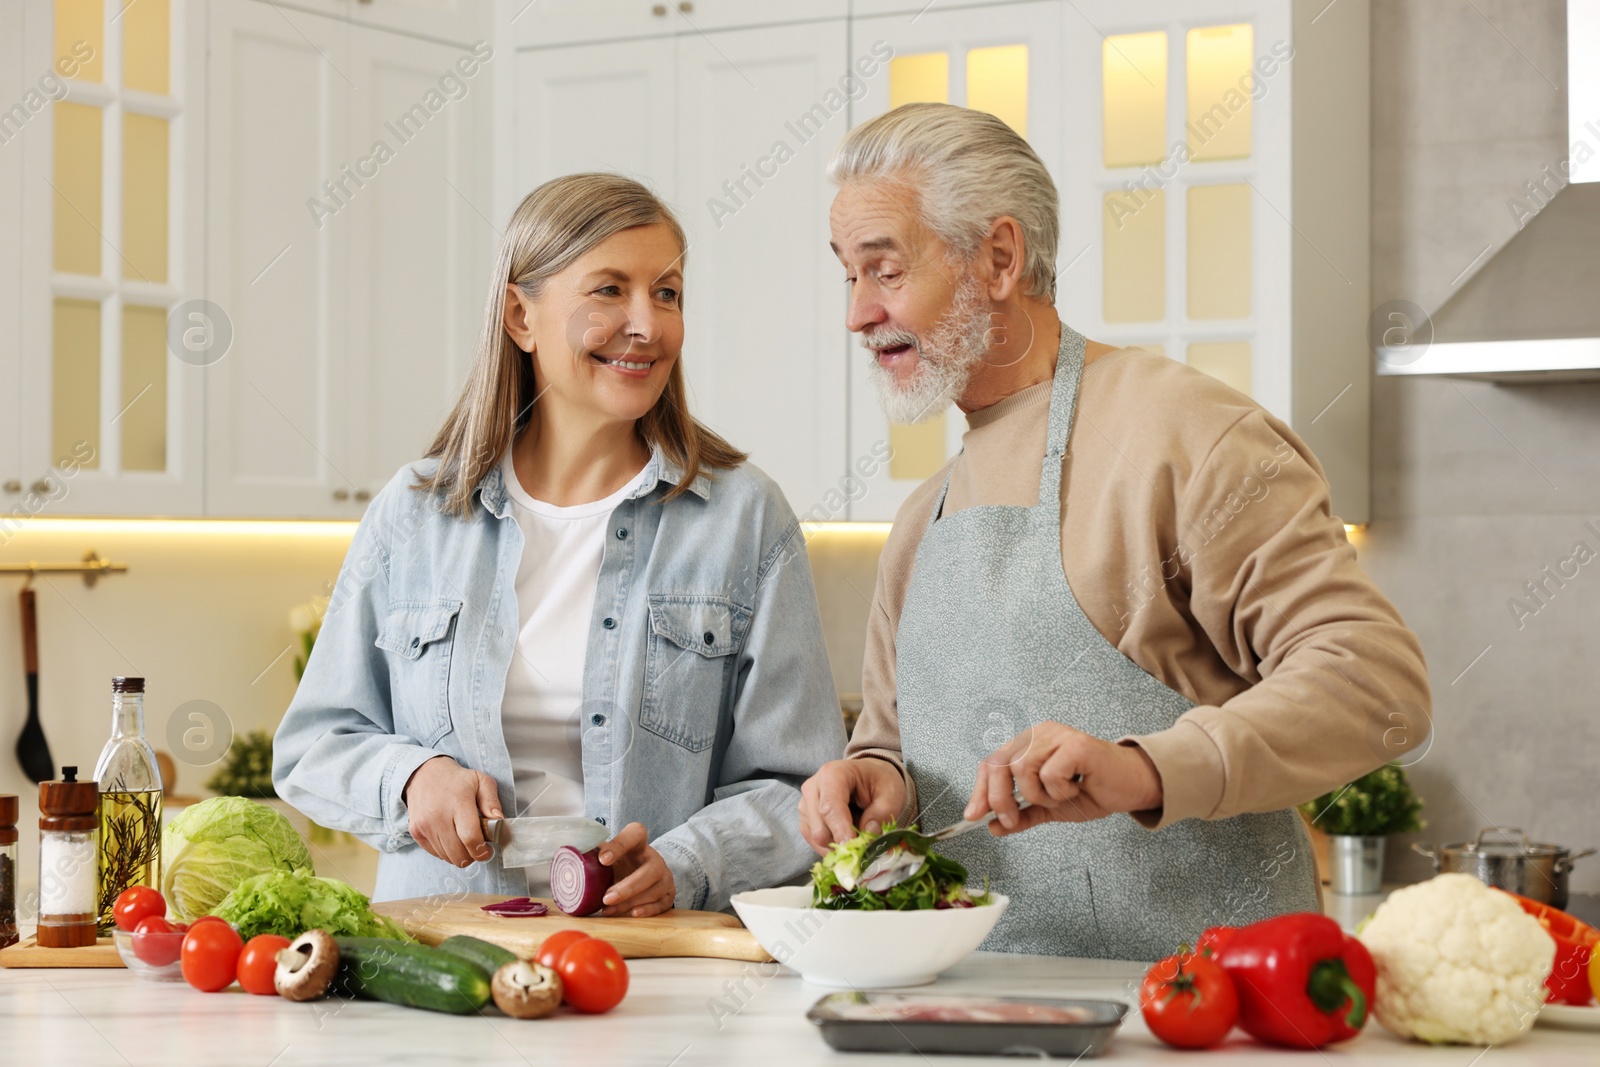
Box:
1301;763;1427;896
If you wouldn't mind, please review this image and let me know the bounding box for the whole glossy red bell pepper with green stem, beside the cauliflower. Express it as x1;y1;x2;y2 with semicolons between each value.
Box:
1202;912;1378;1048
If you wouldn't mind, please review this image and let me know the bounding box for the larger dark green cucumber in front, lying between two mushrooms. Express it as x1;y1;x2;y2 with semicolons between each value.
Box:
333;937;490;1016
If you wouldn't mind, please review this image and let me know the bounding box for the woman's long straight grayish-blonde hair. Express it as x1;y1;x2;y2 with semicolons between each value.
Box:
411;174;746;518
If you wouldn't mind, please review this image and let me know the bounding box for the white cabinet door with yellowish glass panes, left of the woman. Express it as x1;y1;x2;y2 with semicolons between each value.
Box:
38;0;202;514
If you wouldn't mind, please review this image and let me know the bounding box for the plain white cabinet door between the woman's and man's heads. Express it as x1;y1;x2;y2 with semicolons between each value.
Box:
674;19;850;518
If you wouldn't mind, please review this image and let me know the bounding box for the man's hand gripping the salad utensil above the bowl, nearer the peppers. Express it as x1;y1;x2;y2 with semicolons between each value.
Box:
962;723;1162;837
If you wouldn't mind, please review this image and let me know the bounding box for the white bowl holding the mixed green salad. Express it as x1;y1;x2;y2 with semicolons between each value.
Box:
733;886;1010;989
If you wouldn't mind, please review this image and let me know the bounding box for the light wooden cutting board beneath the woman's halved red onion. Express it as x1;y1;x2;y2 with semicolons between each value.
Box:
373;893;771;963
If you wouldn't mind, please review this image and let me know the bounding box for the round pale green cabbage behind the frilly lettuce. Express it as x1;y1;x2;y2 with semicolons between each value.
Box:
162;797;312;923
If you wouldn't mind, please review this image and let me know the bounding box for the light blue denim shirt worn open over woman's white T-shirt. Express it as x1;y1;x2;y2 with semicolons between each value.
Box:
272;451;845;910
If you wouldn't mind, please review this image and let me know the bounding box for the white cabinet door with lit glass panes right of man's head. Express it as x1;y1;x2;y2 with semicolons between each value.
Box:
1059;0;1293;418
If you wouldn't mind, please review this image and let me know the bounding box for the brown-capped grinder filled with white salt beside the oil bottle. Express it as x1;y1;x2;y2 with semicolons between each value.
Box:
37;766;99;949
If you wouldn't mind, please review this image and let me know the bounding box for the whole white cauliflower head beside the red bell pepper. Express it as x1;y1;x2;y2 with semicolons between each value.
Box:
1358;875;1555;1045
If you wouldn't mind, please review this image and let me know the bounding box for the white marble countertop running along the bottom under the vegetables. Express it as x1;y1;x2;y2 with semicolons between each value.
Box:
0;953;1600;1067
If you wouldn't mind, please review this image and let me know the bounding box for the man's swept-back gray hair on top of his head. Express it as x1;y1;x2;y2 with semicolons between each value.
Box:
827;104;1061;299
